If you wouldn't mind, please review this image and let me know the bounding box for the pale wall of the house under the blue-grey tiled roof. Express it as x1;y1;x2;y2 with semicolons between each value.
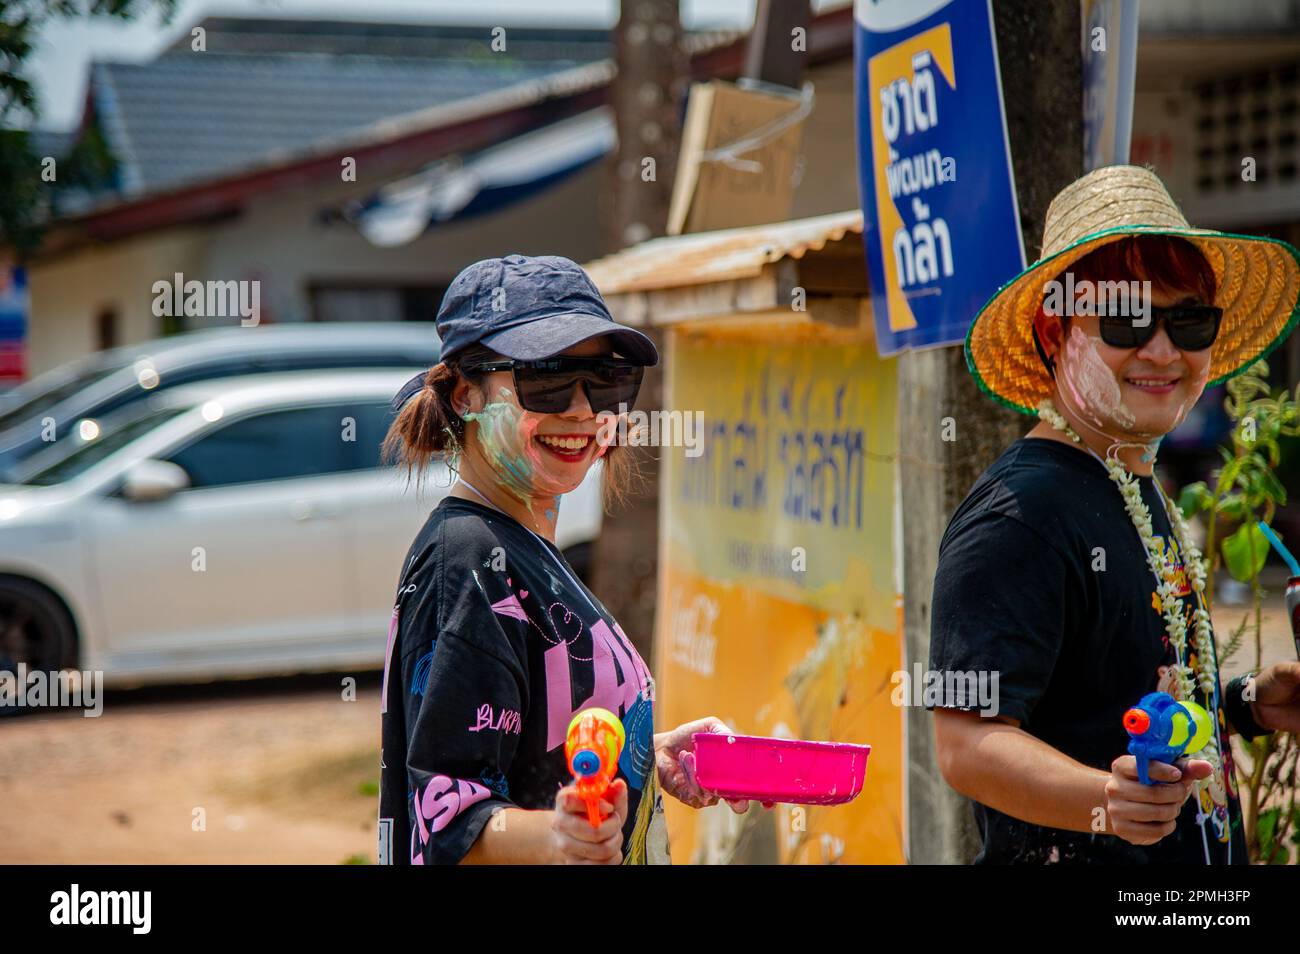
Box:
27;155;603;374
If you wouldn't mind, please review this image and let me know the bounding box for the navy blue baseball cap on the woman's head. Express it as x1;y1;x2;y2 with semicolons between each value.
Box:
393;255;659;408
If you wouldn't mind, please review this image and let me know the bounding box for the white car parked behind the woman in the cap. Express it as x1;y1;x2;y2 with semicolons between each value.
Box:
0;368;602;685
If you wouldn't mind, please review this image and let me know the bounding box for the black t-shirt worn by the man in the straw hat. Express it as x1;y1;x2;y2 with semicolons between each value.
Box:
930;438;1247;864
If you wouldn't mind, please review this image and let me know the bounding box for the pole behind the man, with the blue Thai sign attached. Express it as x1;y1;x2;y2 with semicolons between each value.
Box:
898;0;1083;864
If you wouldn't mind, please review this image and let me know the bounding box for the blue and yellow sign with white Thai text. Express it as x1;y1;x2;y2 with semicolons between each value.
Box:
854;0;1024;355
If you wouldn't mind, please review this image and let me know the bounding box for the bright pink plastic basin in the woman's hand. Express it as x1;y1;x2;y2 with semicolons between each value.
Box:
693;732;871;805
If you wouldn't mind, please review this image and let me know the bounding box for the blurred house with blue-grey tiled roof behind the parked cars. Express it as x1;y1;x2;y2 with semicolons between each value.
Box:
26;8;857;374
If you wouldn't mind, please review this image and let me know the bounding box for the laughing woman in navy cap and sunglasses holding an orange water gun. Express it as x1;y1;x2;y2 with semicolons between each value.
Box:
380;255;748;864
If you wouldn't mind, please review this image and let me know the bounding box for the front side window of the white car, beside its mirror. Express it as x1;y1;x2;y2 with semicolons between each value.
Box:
169;404;366;489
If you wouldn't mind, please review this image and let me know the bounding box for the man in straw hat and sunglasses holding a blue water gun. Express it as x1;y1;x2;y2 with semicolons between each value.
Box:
931;166;1300;864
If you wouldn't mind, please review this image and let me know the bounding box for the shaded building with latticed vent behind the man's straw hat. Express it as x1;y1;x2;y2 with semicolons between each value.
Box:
1131;0;1300;534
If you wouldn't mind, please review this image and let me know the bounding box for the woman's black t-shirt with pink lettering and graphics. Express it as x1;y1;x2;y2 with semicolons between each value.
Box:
380;496;667;864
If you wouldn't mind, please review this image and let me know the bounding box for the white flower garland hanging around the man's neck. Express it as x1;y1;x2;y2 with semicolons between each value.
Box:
1039;399;1216;699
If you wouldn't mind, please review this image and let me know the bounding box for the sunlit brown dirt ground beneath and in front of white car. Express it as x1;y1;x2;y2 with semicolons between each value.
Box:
0;587;1295;864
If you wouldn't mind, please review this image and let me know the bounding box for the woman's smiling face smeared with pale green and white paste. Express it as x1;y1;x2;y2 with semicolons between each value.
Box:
458;338;610;506
